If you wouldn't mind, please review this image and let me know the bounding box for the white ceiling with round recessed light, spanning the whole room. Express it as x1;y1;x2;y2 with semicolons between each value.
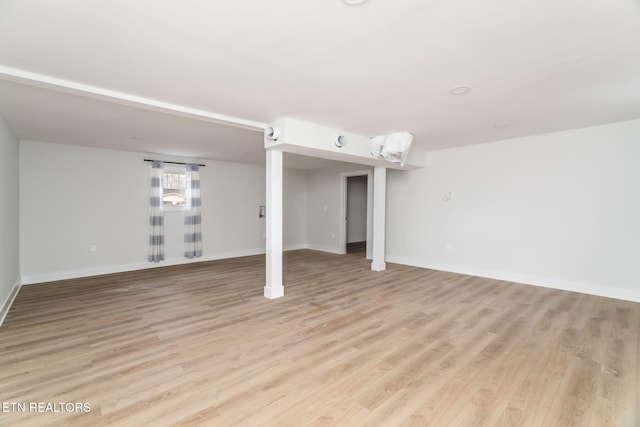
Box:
0;0;640;167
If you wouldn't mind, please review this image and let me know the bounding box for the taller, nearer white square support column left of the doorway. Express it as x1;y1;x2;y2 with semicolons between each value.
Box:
264;149;284;299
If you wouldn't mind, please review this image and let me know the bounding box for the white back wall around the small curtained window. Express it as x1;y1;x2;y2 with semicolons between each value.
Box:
20;141;305;283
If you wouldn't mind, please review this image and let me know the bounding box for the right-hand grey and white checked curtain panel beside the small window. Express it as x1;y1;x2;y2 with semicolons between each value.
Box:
184;164;202;258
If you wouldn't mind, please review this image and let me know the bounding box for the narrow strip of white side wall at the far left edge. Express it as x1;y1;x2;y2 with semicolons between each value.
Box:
0;116;20;324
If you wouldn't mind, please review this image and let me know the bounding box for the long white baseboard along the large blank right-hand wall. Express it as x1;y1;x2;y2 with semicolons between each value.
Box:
386;256;640;302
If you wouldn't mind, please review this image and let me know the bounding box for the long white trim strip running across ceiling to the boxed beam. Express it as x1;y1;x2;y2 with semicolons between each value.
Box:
0;65;266;131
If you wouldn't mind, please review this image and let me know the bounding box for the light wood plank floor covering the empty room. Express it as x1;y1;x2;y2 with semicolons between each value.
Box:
0;250;640;427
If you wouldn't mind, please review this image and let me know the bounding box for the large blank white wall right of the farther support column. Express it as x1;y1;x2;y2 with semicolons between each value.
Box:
387;120;640;301
